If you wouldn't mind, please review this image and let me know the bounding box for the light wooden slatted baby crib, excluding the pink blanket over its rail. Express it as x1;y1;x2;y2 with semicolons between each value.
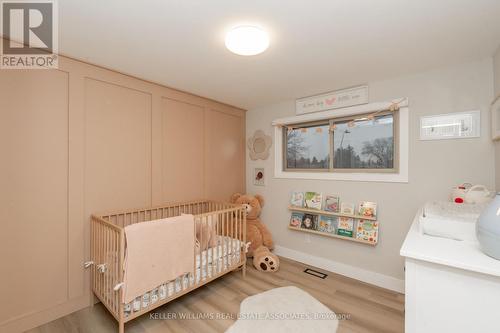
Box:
87;200;246;333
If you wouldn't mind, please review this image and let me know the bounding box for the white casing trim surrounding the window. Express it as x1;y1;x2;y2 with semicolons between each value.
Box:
273;98;409;183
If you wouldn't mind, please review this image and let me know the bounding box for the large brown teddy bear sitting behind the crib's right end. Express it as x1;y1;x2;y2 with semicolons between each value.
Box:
231;193;274;257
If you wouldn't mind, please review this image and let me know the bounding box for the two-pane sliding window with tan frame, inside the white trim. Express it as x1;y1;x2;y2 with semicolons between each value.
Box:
283;111;398;173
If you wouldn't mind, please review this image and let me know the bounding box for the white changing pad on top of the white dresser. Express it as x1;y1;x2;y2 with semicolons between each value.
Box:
419;201;486;242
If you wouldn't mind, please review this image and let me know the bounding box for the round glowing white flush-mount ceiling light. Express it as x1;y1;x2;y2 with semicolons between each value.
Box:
226;25;269;56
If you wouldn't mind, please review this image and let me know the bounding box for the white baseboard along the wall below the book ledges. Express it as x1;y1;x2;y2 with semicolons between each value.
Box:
274;245;405;293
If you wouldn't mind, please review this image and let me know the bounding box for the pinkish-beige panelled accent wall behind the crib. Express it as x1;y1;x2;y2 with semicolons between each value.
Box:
0;53;245;332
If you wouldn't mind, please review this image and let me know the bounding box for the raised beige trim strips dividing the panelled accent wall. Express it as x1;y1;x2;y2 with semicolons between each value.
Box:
0;45;245;332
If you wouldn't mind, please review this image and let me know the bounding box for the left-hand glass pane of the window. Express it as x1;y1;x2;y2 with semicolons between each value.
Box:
286;124;330;169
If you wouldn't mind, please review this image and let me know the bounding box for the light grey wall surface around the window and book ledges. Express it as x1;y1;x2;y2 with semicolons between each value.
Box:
247;59;495;279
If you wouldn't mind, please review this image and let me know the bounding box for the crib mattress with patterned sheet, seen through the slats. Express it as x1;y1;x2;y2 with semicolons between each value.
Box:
123;237;241;317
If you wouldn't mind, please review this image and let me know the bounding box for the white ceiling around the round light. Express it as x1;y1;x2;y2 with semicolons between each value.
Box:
58;0;500;109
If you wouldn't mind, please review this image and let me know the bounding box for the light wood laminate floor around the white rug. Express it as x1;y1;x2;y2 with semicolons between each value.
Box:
28;258;404;333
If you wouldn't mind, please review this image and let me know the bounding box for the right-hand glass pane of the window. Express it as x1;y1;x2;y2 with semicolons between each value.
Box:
333;114;394;169
